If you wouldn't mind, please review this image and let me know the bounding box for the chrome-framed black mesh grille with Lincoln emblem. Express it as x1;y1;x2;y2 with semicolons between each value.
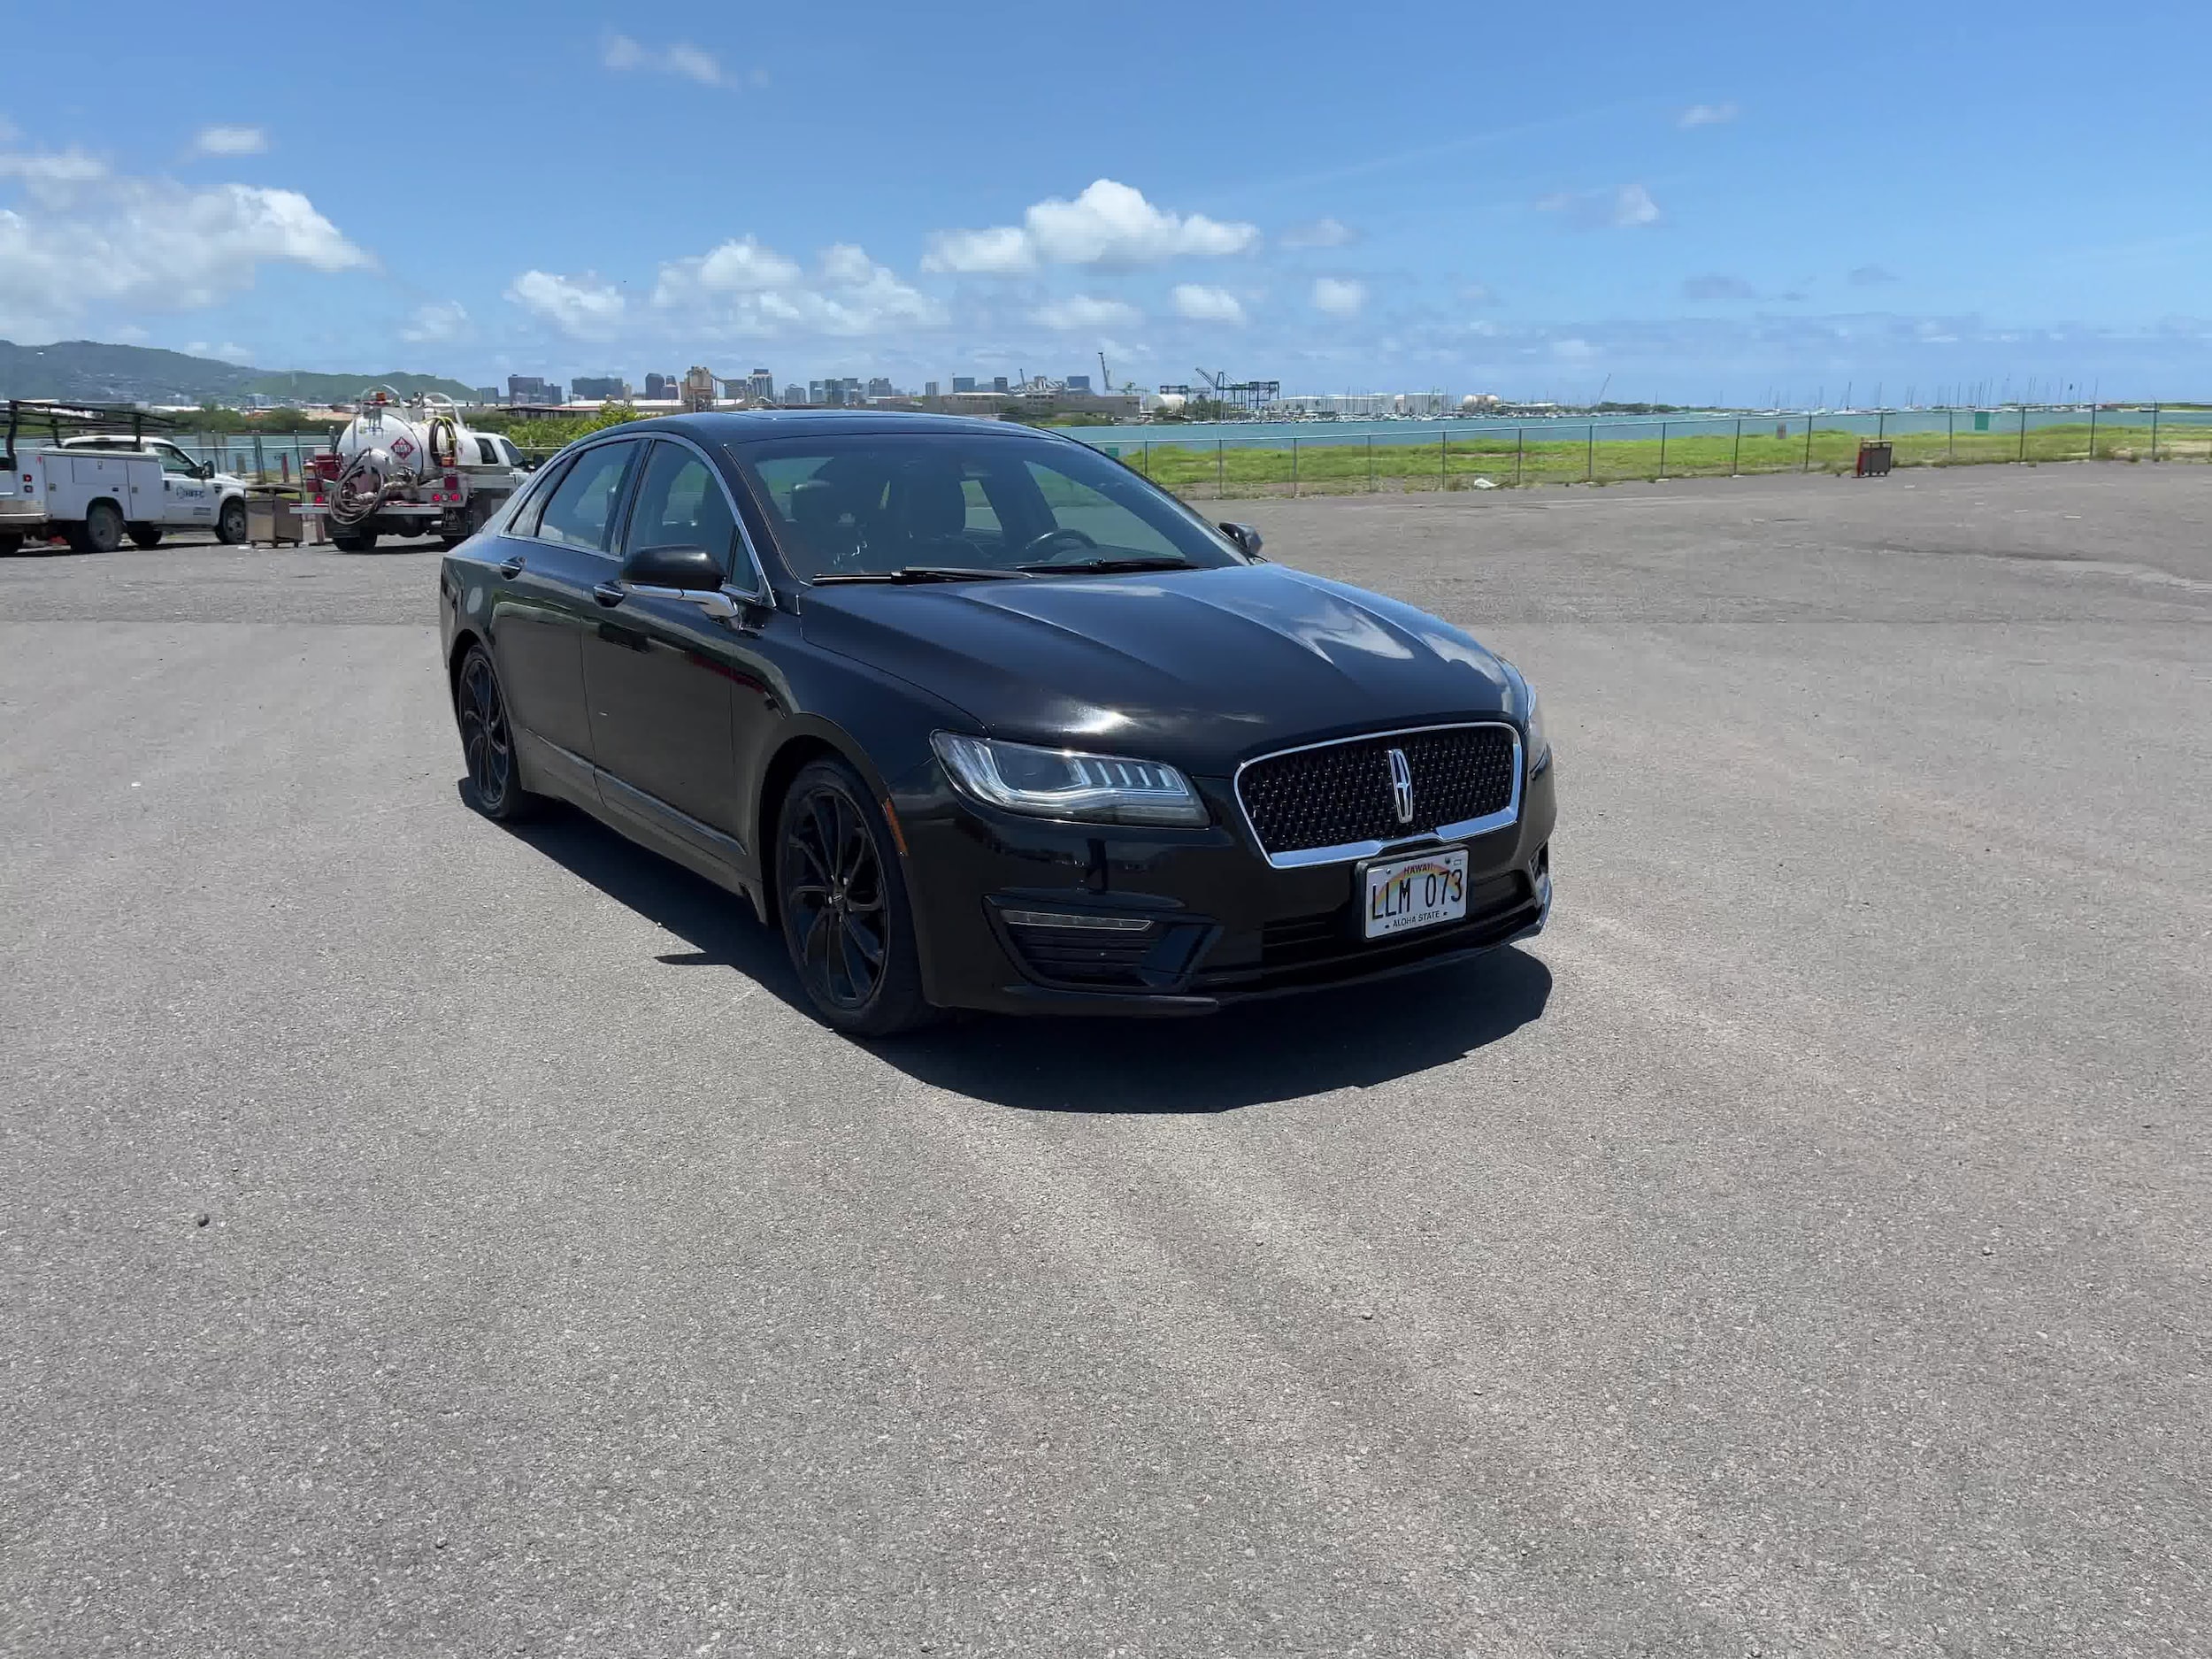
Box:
1237;724;1520;861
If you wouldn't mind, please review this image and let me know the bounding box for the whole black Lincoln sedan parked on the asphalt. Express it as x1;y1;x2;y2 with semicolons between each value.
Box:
441;411;1555;1035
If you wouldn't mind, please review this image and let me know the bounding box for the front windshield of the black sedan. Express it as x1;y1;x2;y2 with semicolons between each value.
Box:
730;432;1246;582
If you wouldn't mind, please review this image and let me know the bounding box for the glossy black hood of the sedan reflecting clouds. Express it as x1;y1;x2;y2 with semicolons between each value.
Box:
803;565;1509;774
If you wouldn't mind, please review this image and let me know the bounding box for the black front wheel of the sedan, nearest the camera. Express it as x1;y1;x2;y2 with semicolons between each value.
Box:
777;761;933;1038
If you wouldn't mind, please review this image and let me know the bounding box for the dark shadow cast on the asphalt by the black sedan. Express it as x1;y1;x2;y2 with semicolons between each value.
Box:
493;786;1551;1113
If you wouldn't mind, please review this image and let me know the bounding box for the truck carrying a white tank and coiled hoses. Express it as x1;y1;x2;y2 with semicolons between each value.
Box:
299;388;529;553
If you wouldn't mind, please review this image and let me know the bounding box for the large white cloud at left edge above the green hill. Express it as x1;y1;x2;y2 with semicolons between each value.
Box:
0;150;374;334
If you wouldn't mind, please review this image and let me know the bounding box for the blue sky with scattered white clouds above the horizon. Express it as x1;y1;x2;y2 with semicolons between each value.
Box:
0;0;2212;403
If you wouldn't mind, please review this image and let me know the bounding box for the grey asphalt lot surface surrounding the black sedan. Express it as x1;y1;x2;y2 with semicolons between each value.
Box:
0;465;2212;1657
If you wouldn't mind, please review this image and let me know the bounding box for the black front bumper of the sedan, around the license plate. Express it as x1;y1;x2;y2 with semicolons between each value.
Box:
894;764;1557;1016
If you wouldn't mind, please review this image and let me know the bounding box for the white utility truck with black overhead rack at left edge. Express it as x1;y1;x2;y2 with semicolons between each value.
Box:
0;398;246;553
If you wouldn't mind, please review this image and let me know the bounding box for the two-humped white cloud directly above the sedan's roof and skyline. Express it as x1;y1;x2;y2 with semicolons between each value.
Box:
653;237;945;339
